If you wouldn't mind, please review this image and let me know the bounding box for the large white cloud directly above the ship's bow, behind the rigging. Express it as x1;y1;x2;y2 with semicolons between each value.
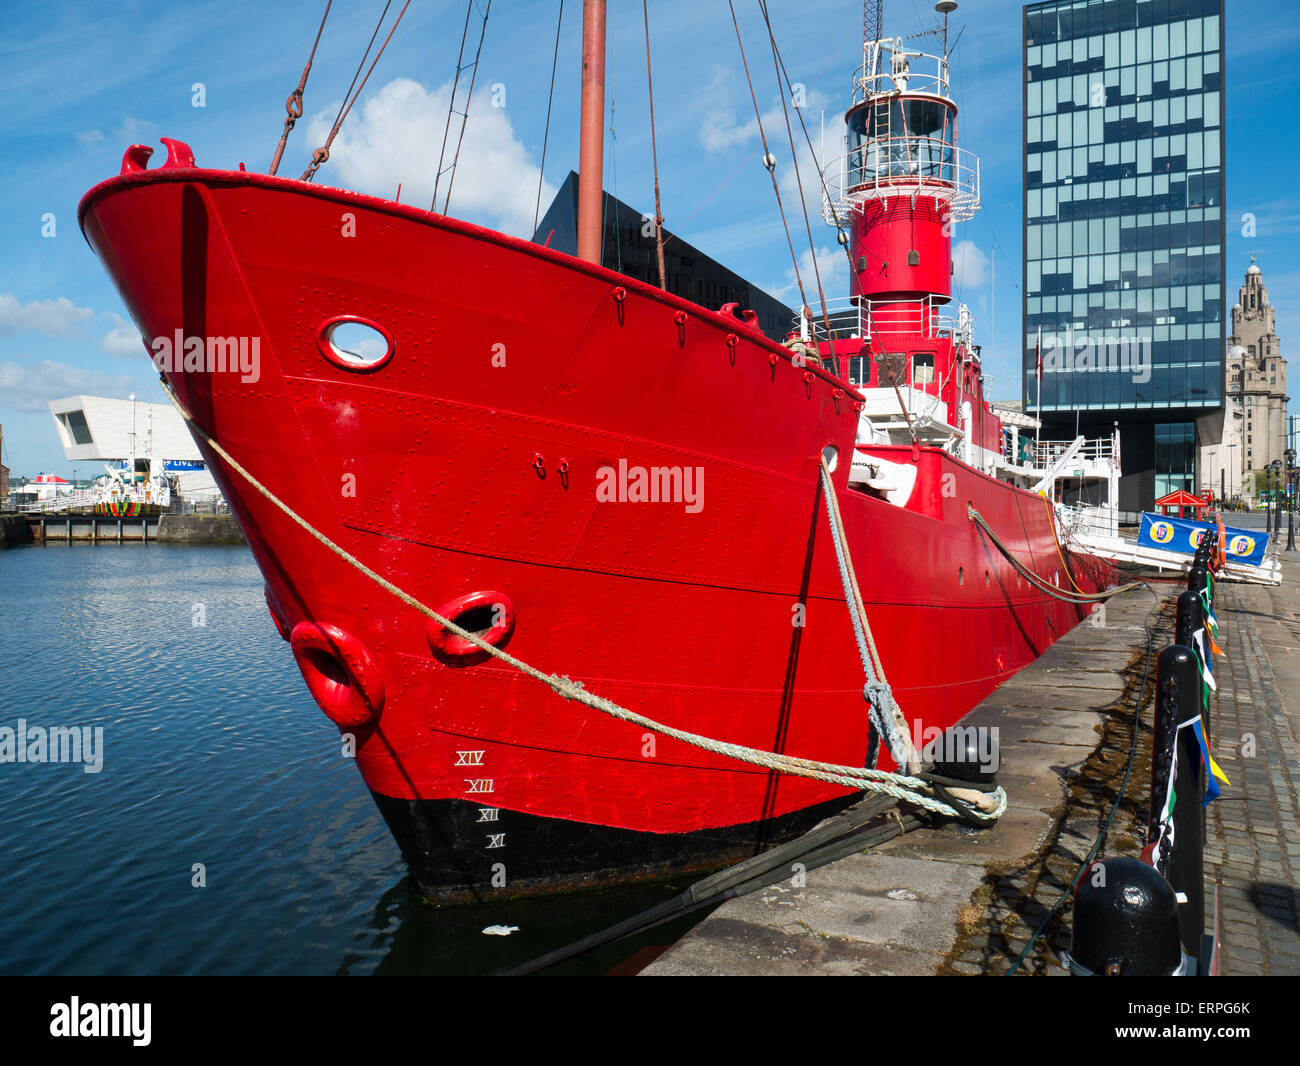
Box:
308;78;555;237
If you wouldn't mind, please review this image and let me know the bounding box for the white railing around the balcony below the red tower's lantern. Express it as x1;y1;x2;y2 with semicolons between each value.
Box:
822;137;979;225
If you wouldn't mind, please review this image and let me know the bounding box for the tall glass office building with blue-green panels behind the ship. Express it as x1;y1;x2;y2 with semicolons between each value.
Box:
1023;0;1225;510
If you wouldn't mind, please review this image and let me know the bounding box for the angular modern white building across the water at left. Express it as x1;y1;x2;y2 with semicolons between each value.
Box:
49;397;221;502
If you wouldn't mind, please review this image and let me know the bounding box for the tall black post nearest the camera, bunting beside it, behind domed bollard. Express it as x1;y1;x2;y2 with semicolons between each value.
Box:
1147;644;1206;958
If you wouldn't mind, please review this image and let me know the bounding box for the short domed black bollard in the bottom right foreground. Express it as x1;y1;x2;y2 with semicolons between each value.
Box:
1065;855;1186;978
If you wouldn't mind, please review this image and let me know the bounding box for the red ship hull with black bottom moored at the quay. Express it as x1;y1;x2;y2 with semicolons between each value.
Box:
81;165;1113;897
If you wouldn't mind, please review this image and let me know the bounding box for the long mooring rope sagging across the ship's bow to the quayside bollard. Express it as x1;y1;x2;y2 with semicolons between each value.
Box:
154;381;1006;823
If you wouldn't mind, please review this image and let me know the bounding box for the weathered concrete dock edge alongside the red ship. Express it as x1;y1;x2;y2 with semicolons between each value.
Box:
642;574;1179;976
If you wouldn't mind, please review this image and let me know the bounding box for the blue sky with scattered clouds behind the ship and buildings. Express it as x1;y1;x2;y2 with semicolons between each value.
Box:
0;0;1300;476
